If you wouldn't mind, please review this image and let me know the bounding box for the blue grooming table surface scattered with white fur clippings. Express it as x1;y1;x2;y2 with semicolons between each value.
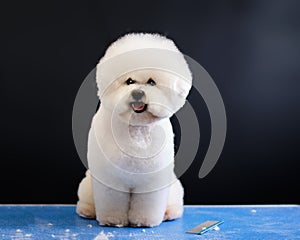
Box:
0;205;300;240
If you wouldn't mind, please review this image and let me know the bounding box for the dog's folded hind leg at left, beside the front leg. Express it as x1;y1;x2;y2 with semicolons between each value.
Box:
76;171;96;218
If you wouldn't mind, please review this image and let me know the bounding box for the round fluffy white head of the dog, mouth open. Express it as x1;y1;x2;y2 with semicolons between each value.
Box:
96;33;192;125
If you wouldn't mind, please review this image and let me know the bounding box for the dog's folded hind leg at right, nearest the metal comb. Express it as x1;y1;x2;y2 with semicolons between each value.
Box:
164;180;183;221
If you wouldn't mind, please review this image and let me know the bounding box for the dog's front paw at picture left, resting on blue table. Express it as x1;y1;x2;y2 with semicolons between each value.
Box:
97;212;128;227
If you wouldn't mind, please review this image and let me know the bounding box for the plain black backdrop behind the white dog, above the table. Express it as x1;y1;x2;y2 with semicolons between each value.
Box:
0;0;300;204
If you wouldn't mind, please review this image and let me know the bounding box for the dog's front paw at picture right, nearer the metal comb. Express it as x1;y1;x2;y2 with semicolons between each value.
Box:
128;208;163;227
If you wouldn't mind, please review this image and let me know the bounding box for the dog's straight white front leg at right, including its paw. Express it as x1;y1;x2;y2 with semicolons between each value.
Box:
128;187;169;227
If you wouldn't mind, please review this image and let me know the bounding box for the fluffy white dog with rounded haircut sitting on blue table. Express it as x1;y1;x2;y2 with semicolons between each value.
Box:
77;33;192;227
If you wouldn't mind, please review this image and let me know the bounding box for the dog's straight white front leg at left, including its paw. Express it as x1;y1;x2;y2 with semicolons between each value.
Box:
93;179;130;227
